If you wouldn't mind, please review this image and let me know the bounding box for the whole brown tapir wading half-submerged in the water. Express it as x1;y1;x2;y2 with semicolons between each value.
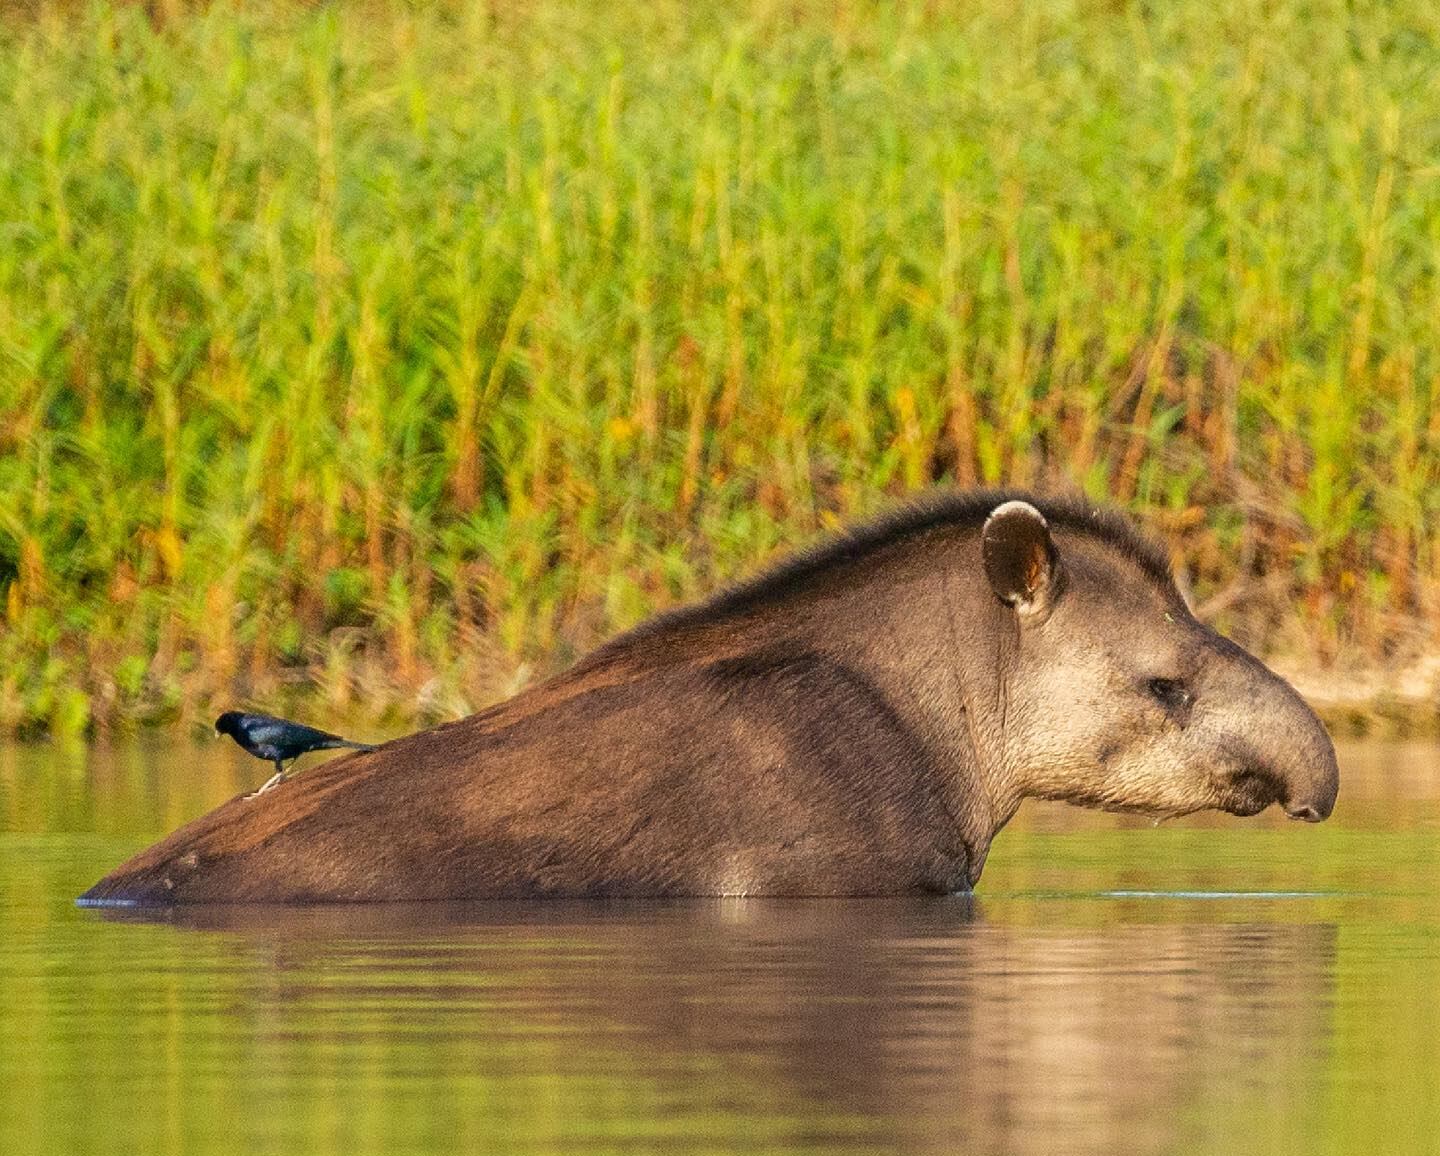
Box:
81;491;1339;904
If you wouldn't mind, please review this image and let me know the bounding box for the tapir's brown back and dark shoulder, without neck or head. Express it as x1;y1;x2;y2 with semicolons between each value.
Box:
84;655;968;903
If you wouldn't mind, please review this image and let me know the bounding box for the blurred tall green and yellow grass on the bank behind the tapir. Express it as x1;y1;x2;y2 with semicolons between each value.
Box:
0;0;1440;733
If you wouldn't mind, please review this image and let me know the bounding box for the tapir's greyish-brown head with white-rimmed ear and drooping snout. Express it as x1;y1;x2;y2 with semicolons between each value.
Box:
981;501;1339;822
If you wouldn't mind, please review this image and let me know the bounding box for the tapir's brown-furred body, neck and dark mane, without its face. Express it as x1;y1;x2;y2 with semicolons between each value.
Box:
84;492;1336;903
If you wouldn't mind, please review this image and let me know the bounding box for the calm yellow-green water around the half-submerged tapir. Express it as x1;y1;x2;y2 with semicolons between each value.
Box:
0;744;1440;1156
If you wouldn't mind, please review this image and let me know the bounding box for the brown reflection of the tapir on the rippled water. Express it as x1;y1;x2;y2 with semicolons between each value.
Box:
75;900;1335;1153
